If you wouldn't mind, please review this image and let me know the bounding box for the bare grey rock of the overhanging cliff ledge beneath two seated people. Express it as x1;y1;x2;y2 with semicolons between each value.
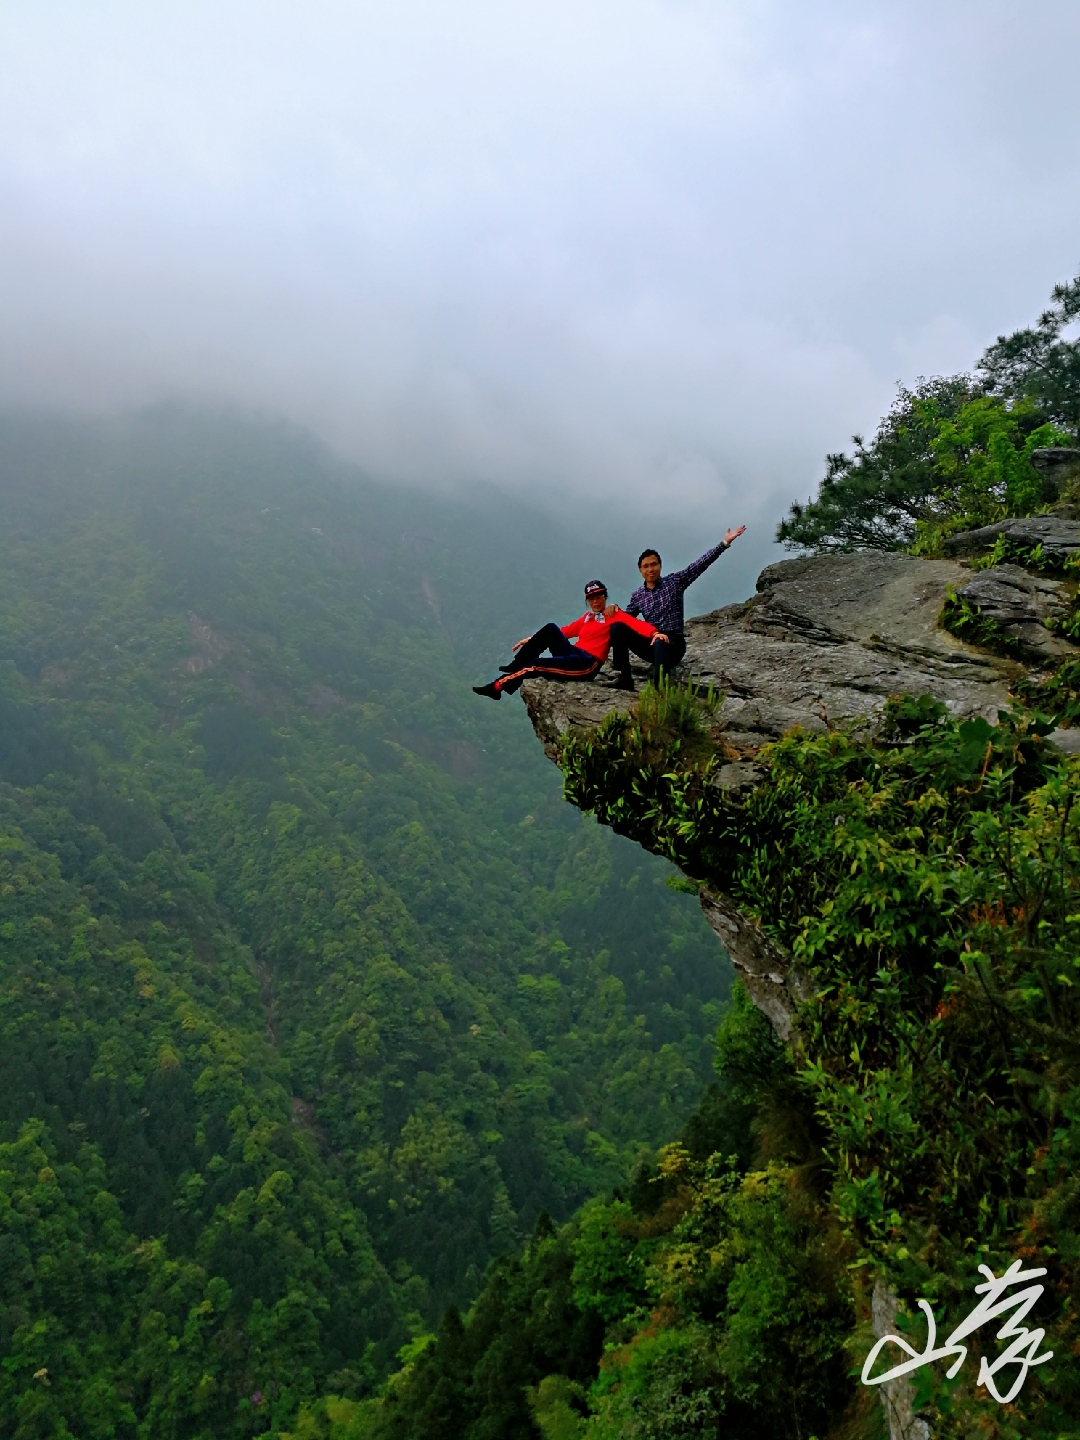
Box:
521;547;1080;1038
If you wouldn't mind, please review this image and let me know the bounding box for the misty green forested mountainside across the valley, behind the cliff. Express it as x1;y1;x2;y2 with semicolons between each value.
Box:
0;410;730;1440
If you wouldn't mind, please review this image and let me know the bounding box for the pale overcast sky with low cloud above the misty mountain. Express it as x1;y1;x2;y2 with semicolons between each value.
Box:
0;0;1080;561
